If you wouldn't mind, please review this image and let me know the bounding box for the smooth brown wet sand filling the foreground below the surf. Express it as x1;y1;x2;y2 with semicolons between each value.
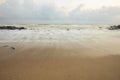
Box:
0;42;120;80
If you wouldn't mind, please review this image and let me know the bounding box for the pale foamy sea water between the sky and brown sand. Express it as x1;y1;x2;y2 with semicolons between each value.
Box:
0;24;120;42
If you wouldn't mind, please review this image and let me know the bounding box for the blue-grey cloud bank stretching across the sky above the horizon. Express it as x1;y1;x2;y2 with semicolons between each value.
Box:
0;0;120;23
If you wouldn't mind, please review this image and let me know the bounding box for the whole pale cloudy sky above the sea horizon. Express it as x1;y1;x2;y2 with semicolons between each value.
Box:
0;0;120;24
